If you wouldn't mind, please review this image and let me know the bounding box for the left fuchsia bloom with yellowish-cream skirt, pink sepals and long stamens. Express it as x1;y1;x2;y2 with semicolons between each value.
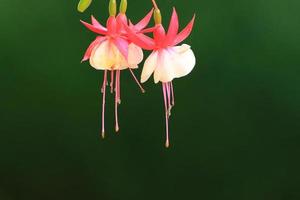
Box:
81;1;153;137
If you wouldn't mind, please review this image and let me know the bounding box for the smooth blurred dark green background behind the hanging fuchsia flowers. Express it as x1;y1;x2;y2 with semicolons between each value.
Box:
0;0;300;200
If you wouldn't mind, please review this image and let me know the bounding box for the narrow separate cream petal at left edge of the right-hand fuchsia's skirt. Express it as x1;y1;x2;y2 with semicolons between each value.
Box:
141;51;158;83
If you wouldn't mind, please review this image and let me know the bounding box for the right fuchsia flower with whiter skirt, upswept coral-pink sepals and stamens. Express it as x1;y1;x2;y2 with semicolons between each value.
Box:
125;5;196;147
